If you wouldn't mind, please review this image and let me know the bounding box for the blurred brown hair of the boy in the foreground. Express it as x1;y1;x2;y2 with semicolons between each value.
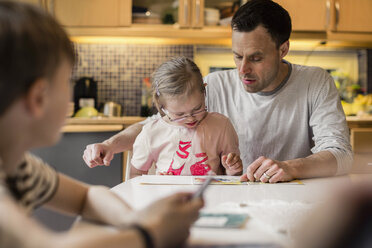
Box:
0;1;75;116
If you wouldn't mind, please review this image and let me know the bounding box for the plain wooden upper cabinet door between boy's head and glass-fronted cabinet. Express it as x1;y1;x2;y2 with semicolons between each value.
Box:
47;0;132;27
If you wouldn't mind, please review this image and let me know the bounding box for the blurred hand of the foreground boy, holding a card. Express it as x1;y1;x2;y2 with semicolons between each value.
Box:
136;193;204;247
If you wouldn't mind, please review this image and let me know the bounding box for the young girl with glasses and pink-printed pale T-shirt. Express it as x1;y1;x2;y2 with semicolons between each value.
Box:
131;57;243;177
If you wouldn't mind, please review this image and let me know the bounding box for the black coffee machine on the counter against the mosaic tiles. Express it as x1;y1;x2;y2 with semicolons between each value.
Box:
74;77;97;113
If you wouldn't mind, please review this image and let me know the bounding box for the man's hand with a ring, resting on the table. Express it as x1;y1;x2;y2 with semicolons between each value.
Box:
240;156;294;183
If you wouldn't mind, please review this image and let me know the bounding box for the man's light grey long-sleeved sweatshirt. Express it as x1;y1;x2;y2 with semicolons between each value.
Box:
205;61;352;175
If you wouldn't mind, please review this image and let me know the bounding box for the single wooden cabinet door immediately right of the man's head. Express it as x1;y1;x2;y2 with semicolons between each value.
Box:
275;0;328;32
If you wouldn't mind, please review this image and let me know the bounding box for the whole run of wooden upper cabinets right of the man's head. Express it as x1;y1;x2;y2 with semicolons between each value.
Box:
274;0;372;42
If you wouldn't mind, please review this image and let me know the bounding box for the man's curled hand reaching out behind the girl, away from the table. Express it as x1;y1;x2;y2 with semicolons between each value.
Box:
83;143;114;168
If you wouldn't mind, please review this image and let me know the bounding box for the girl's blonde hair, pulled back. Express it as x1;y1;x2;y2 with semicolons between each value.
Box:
152;57;205;116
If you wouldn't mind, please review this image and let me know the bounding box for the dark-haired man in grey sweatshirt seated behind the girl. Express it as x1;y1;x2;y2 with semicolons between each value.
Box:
83;0;352;183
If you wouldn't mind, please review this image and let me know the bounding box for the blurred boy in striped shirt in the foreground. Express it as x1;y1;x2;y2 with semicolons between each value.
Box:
0;1;203;248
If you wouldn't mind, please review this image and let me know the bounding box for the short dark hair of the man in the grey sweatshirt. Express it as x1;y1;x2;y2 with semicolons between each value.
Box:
231;0;292;48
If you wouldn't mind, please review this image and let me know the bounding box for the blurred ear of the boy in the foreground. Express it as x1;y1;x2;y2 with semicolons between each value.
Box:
25;78;49;117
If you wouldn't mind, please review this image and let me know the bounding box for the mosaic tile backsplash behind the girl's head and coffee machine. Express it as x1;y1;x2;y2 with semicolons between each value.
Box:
72;43;194;116
